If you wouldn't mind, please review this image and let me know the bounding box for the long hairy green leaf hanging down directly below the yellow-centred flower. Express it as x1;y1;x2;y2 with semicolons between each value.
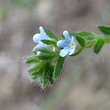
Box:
53;57;65;79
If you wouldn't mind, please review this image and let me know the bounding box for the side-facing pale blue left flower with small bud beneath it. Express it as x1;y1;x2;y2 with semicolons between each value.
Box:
33;26;49;55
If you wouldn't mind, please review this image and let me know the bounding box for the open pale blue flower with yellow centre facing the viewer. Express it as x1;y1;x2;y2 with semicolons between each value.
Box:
57;31;77;57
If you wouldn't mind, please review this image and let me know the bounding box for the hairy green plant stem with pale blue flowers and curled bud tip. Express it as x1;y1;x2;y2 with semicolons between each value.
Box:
25;26;110;88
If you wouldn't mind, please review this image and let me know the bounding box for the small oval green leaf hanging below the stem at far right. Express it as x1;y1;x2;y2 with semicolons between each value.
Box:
93;38;104;54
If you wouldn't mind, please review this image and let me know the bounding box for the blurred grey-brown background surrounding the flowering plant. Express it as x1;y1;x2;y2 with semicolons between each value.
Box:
0;0;110;110
